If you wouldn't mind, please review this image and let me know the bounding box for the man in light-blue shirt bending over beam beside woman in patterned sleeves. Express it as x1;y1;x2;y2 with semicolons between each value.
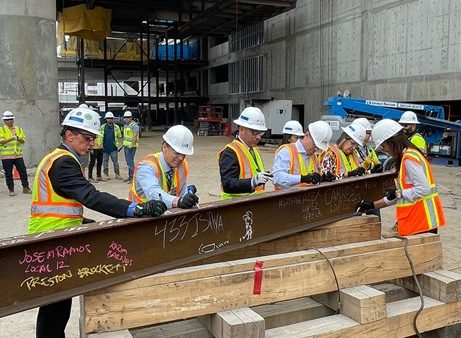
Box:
272;121;333;190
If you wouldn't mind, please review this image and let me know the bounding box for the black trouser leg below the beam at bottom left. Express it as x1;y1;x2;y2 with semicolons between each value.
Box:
36;298;72;338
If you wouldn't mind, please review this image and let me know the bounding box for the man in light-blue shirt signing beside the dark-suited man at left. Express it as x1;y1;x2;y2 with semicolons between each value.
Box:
128;125;199;209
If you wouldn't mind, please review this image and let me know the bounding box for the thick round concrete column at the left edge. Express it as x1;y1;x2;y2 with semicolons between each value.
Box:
0;0;60;167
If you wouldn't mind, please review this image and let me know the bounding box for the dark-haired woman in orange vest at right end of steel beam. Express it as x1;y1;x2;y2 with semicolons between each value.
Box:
357;119;445;236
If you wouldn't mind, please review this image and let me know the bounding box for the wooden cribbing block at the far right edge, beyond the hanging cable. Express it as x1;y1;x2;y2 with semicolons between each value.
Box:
395;270;461;303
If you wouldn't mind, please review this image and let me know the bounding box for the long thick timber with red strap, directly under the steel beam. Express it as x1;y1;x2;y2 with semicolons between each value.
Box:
84;235;442;332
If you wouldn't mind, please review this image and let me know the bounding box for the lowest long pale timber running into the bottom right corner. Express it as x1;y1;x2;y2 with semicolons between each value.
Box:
266;297;461;338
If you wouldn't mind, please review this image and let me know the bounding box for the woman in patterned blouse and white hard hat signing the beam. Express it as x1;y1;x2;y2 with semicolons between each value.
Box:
320;125;366;178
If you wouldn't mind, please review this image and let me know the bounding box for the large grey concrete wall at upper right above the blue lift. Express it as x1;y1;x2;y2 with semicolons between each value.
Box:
211;0;461;122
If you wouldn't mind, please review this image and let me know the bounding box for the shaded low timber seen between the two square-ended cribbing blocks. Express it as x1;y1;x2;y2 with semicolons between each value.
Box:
252;297;334;330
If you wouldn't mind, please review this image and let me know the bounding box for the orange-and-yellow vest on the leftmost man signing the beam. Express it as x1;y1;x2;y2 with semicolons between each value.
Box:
28;148;83;233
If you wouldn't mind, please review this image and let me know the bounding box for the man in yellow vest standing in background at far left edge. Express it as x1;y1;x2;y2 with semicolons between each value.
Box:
0;111;32;196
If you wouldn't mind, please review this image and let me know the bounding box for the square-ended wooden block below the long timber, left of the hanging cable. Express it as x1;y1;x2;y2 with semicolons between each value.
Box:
340;285;387;324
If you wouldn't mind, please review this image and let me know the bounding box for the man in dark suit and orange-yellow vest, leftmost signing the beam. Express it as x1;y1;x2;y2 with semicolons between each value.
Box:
28;108;167;338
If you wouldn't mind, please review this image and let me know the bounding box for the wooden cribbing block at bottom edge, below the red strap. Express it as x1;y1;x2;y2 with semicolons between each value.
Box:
200;308;265;338
